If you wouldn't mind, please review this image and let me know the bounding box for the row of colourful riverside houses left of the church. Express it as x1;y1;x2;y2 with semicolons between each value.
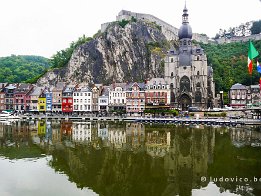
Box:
0;78;170;116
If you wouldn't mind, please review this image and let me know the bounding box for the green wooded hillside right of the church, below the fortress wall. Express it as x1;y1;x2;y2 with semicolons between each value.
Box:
200;40;261;92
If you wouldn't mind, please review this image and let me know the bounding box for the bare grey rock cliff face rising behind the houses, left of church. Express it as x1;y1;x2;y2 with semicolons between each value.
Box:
38;21;168;86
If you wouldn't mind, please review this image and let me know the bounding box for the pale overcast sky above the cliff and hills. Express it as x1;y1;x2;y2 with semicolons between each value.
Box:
0;0;261;57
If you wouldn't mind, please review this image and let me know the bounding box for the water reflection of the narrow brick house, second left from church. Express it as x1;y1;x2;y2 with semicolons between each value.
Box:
126;123;145;150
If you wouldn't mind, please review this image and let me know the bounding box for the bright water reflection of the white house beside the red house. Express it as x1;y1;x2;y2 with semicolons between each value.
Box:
72;122;92;142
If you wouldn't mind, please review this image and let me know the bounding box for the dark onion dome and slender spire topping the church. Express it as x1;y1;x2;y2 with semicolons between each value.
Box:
178;5;192;39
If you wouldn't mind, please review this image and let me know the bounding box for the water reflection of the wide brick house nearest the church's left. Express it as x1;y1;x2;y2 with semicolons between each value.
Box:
145;131;170;157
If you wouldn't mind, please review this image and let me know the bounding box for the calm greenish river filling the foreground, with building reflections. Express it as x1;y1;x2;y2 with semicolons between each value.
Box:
0;120;261;196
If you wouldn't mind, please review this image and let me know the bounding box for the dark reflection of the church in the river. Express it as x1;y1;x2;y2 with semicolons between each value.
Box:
164;127;215;195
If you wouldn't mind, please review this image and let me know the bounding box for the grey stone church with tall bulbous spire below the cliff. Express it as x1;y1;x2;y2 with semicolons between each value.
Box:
164;5;215;110
